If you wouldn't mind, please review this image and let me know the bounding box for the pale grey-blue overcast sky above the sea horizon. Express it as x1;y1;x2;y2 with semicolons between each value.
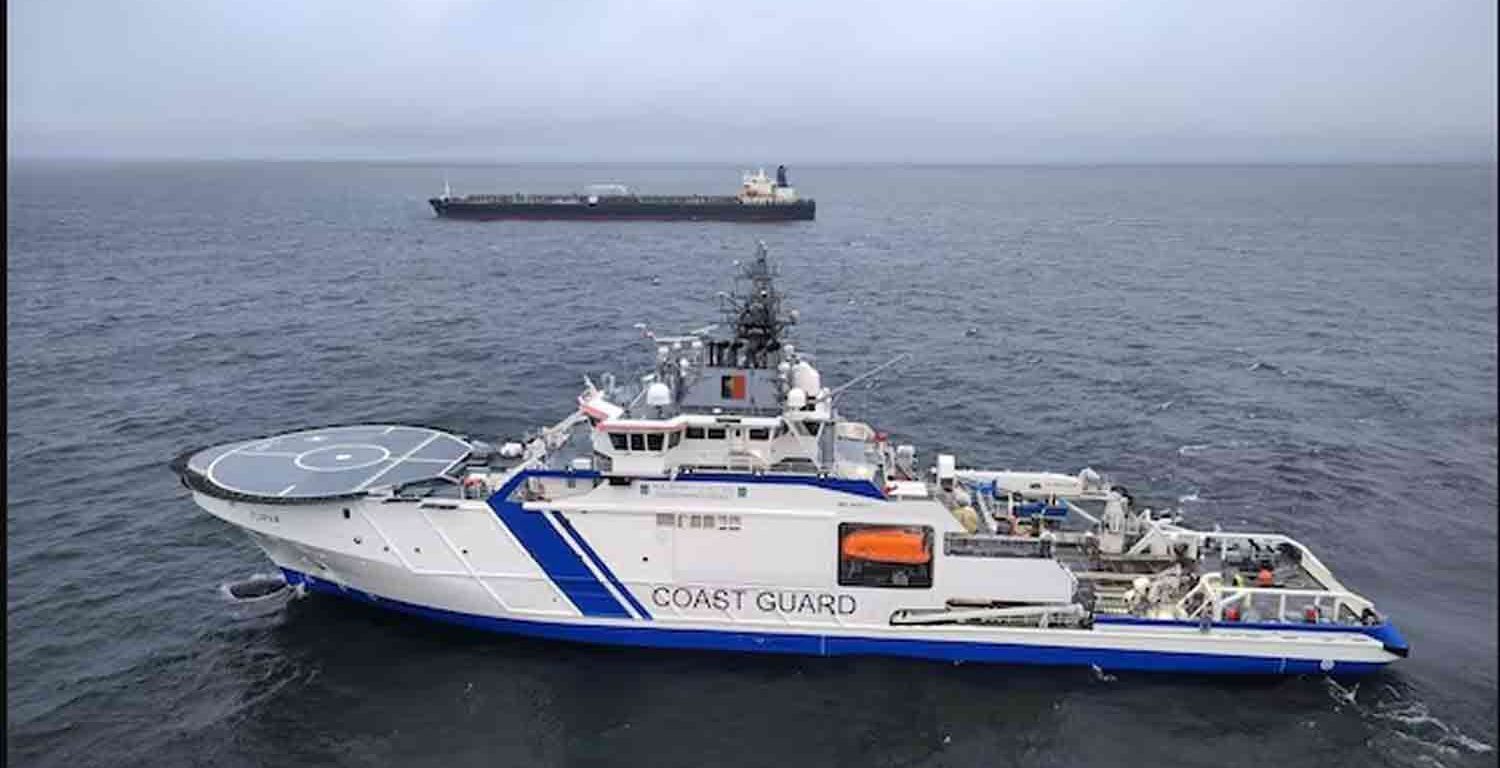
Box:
6;0;1497;162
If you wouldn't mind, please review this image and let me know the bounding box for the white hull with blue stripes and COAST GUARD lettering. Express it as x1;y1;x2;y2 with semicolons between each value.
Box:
195;468;1398;675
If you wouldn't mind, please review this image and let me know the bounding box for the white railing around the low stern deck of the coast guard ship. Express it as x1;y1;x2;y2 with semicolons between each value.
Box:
1175;573;1376;626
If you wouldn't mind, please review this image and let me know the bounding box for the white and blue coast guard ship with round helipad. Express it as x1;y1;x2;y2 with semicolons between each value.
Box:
174;246;1407;675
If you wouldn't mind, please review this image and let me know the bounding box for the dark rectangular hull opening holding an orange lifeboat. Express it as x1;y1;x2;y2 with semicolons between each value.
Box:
839;522;933;590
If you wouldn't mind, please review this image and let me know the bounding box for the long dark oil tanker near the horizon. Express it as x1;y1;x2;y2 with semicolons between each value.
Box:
428;165;818;222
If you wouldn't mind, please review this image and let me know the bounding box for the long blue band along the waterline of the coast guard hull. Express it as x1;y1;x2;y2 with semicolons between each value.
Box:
282;569;1385;675
